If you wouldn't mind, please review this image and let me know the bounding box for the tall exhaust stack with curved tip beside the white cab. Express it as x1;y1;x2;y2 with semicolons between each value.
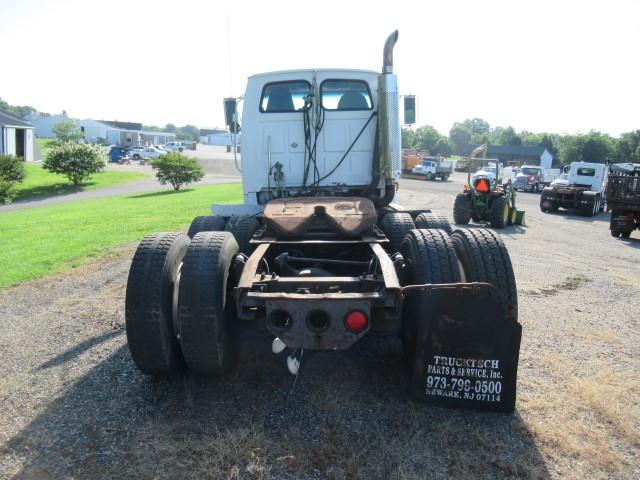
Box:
378;30;402;185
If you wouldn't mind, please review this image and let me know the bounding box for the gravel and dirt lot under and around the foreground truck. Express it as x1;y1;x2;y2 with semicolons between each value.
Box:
0;174;640;479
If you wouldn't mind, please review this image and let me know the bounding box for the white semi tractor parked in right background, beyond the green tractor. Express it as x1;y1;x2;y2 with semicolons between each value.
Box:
540;162;607;217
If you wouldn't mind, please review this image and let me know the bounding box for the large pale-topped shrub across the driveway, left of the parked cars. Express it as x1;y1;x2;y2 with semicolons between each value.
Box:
42;142;106;185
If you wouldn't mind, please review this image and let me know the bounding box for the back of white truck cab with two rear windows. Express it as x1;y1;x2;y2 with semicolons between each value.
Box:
241;69;379;204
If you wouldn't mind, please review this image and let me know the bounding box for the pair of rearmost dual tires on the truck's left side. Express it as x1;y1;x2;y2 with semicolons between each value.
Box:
125;232;238;377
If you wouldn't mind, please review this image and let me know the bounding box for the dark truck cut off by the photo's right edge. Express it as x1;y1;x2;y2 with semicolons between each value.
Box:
607;163;640;238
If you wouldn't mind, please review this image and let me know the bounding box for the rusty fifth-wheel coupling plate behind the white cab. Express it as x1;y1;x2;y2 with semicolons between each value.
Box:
263;197;378;237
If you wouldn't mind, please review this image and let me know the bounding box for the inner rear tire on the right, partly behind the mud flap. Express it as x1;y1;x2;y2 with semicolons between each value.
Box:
400;229;460;365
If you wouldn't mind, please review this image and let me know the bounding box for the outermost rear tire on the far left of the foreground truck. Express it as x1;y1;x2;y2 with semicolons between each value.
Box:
125;233;189;377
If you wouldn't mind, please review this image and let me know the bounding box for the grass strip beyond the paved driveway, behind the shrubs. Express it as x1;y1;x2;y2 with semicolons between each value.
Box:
15;163;148;200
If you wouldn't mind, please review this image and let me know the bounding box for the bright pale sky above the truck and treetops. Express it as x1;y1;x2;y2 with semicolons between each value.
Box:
0;0;640;135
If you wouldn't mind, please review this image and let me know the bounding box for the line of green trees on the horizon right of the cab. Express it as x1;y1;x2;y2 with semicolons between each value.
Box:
402;118;640;165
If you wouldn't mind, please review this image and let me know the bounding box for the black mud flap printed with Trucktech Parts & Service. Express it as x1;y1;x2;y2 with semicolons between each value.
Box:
410;288;522;413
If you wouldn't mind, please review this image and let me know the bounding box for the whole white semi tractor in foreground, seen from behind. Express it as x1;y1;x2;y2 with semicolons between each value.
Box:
125;31;521;412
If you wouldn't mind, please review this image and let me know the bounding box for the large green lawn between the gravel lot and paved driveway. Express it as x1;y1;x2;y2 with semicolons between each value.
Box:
0;185;242;287
